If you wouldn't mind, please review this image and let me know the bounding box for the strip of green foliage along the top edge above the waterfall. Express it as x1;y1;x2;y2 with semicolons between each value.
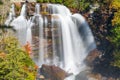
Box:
37;0;90;11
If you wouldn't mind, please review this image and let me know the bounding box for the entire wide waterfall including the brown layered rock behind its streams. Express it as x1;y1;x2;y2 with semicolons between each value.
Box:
5;4;96;80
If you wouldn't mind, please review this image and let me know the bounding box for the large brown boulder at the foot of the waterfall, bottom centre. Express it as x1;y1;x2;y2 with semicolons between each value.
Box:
40;64;70;80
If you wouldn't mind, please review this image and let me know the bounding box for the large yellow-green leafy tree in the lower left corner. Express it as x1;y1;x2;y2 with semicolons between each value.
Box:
0;37;36;80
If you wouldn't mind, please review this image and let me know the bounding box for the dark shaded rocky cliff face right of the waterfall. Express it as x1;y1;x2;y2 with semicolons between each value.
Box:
83;5;120;80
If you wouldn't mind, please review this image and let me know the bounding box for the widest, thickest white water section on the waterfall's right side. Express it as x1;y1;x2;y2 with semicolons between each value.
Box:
48;4;96;74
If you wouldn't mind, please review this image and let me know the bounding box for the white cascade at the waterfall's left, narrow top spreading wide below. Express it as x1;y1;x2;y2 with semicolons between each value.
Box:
10;4;34;45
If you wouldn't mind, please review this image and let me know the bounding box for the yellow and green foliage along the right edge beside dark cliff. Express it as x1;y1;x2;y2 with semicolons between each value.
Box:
110;0;120;67
